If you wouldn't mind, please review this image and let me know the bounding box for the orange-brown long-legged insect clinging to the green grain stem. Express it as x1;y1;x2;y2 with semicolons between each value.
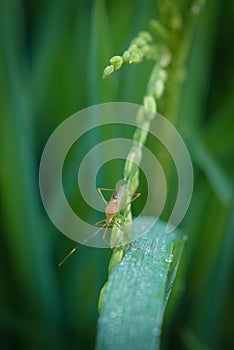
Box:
58;179;141;266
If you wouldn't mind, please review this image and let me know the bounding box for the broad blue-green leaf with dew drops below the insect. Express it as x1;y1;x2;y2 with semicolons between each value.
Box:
96;217;184;350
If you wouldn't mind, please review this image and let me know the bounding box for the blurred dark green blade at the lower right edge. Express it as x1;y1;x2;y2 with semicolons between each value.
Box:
190;196;234;349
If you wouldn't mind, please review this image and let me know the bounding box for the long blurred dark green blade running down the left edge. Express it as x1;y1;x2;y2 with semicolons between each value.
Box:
0;2;58;336
